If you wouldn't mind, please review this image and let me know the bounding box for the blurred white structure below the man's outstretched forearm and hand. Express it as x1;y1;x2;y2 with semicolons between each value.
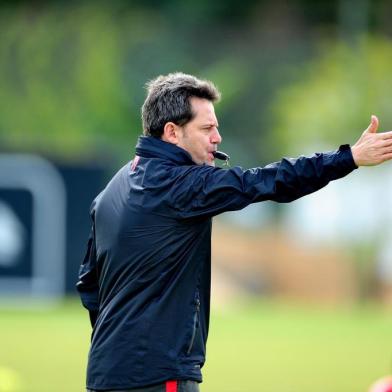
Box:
283;163;392;283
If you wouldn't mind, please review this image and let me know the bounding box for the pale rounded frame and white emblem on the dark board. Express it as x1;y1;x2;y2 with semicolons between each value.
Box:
0;154;66;299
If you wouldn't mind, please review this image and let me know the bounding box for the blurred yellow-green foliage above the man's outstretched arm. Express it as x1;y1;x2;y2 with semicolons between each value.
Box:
270;36;392;155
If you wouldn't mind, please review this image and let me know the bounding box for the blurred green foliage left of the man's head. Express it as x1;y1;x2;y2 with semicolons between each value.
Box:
0;6;140;162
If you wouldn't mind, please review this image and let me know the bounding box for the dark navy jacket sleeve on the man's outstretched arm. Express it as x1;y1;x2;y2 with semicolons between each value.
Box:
172;145;357;218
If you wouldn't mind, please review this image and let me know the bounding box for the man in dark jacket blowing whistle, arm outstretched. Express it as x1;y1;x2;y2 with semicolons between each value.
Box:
77;73;392;392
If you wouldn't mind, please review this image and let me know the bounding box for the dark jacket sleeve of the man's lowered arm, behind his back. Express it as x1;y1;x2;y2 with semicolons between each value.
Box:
76;205;99;327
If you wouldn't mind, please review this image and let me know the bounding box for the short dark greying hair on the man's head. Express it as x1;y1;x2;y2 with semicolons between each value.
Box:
142;72;220;138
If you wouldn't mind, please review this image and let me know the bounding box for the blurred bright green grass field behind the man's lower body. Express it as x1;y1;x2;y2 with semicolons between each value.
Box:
0;299;392;392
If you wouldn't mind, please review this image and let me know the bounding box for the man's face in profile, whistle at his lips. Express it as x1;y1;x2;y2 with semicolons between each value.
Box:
177;97;222;166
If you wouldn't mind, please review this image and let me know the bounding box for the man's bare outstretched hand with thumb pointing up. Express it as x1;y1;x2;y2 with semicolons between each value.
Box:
351;115;392;166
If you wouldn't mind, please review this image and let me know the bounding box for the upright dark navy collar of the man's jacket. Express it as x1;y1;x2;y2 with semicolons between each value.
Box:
136;136;195;165
